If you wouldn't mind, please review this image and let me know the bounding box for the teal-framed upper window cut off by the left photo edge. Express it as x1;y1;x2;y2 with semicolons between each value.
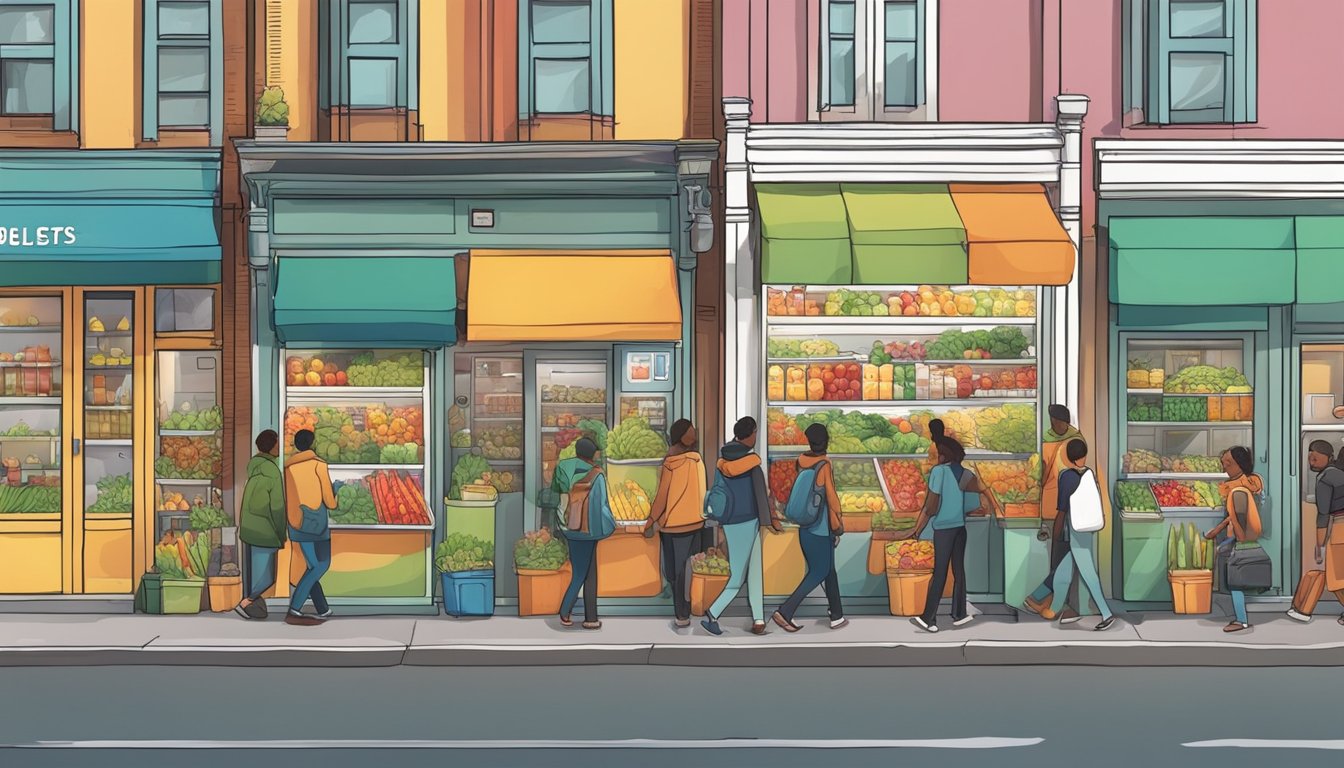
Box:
0;0;79;130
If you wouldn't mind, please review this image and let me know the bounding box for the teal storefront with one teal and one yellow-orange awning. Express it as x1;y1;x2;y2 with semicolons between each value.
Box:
241;143;716;612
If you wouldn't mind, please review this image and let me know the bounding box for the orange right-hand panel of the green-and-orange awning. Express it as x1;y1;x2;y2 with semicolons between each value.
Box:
949;184;1075;285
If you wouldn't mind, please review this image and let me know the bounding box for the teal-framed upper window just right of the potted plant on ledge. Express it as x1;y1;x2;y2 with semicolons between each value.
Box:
323;0;419;109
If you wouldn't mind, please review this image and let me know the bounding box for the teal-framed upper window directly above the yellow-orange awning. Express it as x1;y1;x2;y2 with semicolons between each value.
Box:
519;0;616;120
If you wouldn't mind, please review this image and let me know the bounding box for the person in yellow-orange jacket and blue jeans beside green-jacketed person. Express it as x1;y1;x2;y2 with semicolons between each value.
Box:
285;429;336;627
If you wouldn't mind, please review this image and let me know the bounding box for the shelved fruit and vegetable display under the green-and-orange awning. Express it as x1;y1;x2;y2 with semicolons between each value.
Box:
762;285;1050;597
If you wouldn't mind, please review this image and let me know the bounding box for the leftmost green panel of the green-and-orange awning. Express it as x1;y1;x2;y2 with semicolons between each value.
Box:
755;184;853;285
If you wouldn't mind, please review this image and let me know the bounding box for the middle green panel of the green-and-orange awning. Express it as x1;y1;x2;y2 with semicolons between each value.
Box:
840;184;966;285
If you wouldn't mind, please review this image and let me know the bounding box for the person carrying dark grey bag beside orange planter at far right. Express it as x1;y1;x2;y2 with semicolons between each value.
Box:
1204;445;1274;632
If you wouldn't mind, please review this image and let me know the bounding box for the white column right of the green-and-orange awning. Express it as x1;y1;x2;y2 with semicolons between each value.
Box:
1054;94;1089;417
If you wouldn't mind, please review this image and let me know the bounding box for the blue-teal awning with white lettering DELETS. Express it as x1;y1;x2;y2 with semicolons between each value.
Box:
0;198;220;286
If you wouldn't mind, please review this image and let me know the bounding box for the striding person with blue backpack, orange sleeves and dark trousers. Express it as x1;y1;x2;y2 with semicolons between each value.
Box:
771;424;849;632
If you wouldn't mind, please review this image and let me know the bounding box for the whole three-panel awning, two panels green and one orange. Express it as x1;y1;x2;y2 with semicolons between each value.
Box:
755;183;1074;285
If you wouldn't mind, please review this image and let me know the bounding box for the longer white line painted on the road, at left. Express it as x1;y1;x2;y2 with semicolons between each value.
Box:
3;737;1044;749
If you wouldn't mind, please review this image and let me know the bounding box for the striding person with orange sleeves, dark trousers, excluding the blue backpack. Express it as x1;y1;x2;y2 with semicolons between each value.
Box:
771;424;849;632
